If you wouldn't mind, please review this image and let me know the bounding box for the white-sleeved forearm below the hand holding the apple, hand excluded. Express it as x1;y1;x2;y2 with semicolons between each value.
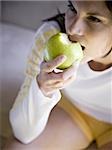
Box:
10;79;61;144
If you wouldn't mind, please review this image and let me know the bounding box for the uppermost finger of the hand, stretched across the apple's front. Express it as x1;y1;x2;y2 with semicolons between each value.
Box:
41;55;66;72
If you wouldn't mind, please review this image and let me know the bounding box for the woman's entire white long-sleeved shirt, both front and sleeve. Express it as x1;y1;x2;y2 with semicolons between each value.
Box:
10;21;112;143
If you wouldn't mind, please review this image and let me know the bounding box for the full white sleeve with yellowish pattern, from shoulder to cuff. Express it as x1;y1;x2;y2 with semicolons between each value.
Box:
9;23;61;144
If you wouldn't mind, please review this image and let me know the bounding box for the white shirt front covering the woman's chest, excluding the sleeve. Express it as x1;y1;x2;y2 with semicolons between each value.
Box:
63;64;112;123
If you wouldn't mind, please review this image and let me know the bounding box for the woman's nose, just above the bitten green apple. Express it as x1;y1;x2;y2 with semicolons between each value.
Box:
67;19;86;36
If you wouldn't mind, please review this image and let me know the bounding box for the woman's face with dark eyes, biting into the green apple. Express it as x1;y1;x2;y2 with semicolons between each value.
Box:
65;1;112;63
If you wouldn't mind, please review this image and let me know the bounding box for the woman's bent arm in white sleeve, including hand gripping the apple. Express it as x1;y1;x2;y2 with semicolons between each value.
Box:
10;21;76;144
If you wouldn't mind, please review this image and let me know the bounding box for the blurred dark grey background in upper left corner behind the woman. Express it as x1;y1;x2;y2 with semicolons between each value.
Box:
1;0;67;30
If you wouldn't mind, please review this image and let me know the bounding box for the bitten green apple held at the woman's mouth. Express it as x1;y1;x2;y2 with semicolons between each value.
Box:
45;32;83;70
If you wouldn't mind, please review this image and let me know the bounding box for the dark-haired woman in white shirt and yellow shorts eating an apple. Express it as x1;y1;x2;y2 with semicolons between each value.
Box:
3;1;112;150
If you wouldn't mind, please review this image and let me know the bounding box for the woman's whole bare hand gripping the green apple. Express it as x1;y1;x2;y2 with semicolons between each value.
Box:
38;55;79;95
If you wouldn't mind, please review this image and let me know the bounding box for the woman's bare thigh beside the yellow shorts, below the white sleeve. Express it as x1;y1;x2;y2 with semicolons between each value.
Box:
4;107;89;150
